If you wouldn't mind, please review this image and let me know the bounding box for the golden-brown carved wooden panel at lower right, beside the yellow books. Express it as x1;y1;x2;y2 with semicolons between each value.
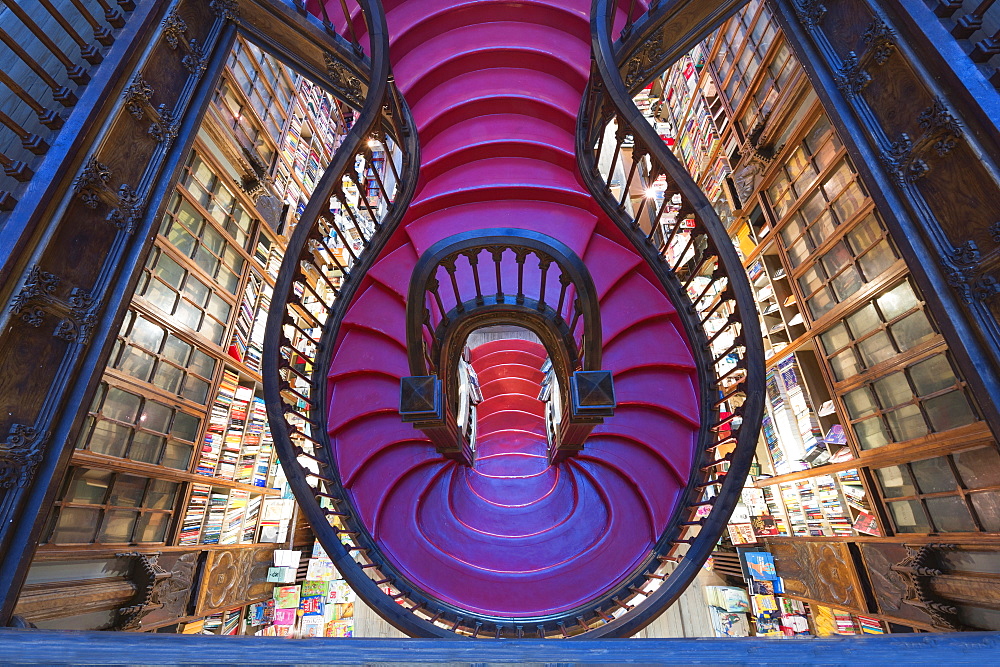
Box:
768;542;867;612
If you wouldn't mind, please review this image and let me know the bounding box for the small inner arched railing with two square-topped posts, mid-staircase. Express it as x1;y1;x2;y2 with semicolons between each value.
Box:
400;228;615;465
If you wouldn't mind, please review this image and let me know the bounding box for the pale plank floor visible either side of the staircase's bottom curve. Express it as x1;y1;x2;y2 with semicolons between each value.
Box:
354;570;724;639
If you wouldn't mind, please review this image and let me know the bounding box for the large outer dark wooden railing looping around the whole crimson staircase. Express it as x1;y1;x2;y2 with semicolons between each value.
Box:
264;0;763;638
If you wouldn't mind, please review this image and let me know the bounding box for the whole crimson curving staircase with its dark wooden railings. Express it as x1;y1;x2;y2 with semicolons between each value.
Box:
265;0;763;638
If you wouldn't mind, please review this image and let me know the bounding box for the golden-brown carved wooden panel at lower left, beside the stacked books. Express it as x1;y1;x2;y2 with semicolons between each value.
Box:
195;545;274;616
